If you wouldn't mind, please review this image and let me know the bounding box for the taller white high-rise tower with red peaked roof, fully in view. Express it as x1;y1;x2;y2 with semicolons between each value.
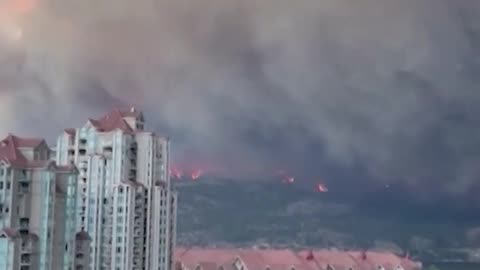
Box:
56;108;176;270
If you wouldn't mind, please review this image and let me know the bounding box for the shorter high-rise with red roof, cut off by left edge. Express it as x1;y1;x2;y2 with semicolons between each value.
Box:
0;135;89;270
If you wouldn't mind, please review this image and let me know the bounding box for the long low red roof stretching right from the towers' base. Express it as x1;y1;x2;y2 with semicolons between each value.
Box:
175;248;421;270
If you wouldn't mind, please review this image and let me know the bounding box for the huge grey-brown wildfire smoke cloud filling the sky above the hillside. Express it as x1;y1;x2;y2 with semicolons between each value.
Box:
0;0;480;193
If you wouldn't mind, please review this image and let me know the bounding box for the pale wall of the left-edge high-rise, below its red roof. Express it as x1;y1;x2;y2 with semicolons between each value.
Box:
0;164;75;270
